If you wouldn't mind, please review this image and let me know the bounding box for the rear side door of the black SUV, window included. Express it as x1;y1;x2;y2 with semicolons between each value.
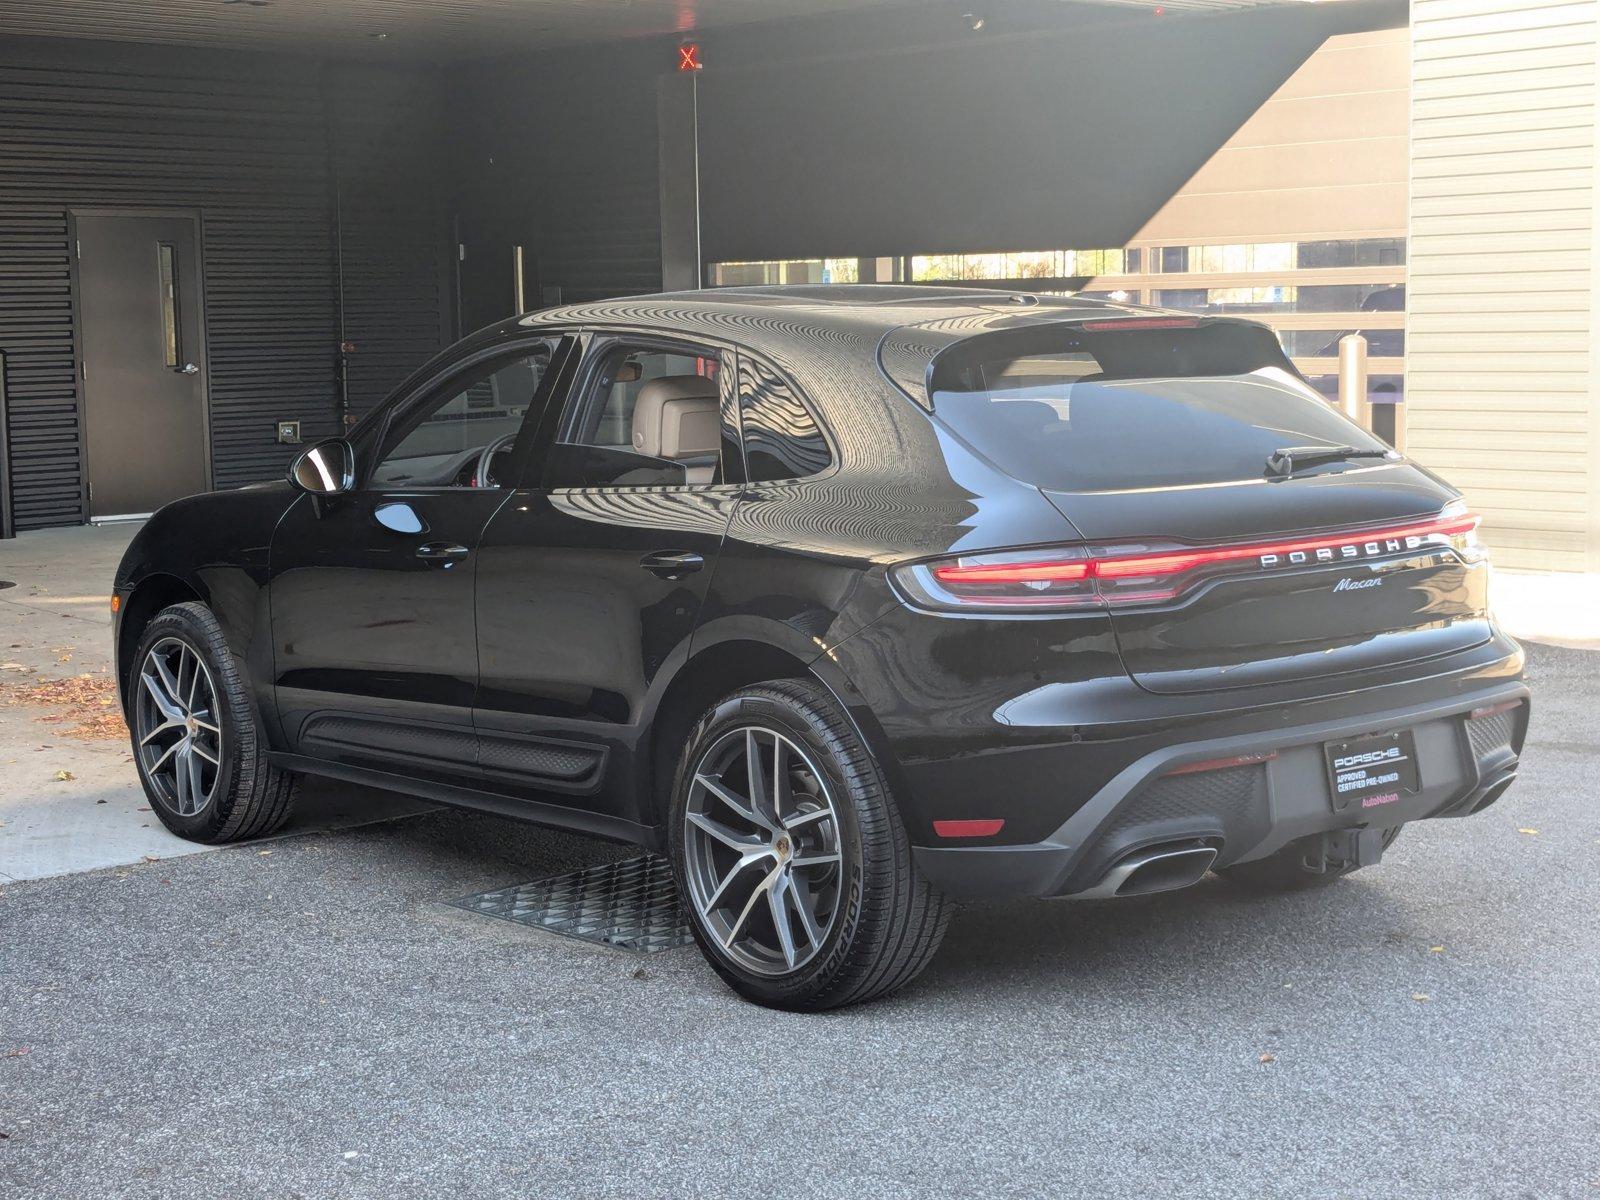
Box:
475;334;742;832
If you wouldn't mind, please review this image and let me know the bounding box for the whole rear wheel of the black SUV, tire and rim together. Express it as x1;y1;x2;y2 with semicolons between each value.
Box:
670;680;949;1010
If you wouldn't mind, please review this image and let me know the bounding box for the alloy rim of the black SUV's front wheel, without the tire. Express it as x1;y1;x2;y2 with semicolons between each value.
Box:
133;637;222;816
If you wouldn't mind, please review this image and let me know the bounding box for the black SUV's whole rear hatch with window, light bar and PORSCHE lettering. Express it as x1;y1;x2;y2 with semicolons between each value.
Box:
930;318;1491;693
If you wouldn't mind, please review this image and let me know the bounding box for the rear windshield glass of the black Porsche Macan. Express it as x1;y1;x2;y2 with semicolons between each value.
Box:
930;323;1384;491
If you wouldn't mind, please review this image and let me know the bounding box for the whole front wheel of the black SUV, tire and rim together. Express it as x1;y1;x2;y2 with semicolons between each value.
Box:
125;603;298;843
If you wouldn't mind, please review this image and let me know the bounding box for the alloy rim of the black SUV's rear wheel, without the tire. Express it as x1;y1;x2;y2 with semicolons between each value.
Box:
683;725;842;974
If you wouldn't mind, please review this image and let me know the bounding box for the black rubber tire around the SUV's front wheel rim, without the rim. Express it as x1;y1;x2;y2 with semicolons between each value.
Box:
126;603;299;843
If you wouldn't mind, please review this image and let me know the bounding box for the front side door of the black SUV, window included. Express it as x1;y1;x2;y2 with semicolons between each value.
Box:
270;338;568;784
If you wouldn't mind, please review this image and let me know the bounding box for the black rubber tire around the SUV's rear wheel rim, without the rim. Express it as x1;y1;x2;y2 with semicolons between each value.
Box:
669;680;949;1011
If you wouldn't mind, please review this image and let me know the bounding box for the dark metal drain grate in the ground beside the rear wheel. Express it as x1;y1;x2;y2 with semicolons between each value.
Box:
451;854;694;952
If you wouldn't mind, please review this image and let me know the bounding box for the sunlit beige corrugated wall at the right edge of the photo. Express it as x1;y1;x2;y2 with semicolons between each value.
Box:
1406;0;1600;571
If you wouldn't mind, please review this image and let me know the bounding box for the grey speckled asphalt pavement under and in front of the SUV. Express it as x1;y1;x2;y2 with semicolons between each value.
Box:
0;646;1600;1200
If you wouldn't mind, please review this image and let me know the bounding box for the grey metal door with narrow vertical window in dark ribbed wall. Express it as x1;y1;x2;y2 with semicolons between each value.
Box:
77;214;210;517
